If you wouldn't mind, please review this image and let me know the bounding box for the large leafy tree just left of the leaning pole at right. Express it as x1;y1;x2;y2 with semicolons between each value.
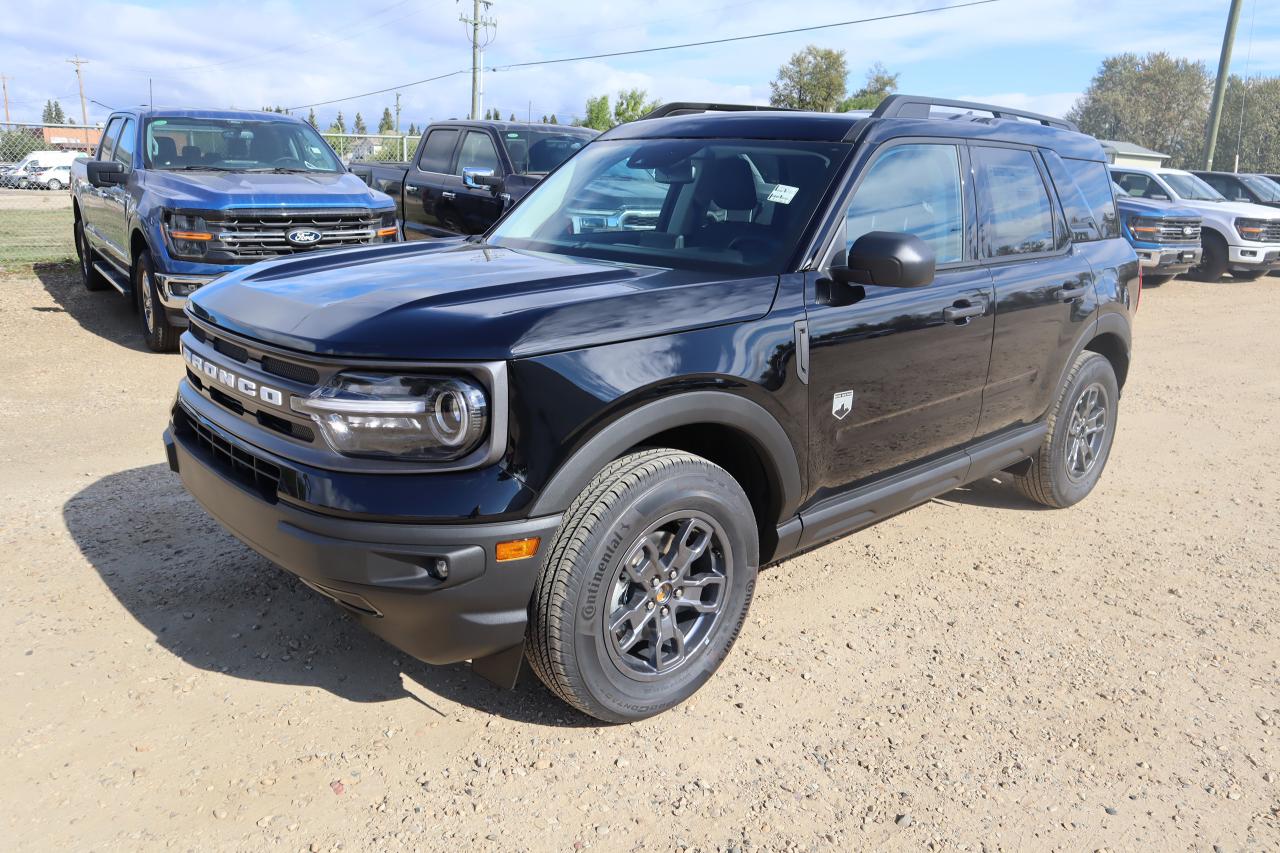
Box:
1066;53;1213;168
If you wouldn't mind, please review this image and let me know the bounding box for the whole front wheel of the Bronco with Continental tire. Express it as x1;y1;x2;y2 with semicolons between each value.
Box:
526;450;759;722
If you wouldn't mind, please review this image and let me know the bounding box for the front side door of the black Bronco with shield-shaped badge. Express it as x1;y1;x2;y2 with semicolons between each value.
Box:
808;142;995;500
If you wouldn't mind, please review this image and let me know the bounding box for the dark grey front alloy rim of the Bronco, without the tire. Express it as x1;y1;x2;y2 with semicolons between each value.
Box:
604;511;732;680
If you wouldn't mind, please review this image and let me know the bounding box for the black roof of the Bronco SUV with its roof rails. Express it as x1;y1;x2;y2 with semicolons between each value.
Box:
600;95;1106;161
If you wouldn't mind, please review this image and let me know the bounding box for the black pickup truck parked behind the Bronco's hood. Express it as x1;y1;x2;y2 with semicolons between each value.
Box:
351;122;596;240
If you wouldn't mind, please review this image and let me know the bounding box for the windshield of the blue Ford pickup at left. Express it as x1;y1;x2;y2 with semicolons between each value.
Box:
146;118;343;173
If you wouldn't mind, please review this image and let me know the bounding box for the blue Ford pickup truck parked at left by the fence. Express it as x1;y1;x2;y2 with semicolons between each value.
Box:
72;109;401;352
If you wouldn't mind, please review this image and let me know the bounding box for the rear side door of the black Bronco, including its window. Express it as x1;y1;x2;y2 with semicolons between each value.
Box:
970;143;1097;435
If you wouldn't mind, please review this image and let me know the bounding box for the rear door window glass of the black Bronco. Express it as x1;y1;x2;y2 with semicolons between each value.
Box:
972;146;1053;257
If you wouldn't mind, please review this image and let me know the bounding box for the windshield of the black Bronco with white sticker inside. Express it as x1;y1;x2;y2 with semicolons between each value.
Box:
489;140;849;275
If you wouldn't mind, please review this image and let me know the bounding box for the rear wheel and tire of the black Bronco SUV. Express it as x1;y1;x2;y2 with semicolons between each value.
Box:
1014;351;1120;508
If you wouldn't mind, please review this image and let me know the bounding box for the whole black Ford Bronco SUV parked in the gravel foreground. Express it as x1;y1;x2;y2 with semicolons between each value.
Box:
165;96;1140;721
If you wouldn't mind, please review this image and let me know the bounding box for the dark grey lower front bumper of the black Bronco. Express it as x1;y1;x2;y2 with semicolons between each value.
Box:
164;403;561;666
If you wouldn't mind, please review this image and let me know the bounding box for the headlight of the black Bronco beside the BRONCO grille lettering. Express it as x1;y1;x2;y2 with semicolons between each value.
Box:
292;373;489;462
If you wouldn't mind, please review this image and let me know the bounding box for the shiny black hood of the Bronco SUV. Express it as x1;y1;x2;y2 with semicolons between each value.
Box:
187;240;778;361
